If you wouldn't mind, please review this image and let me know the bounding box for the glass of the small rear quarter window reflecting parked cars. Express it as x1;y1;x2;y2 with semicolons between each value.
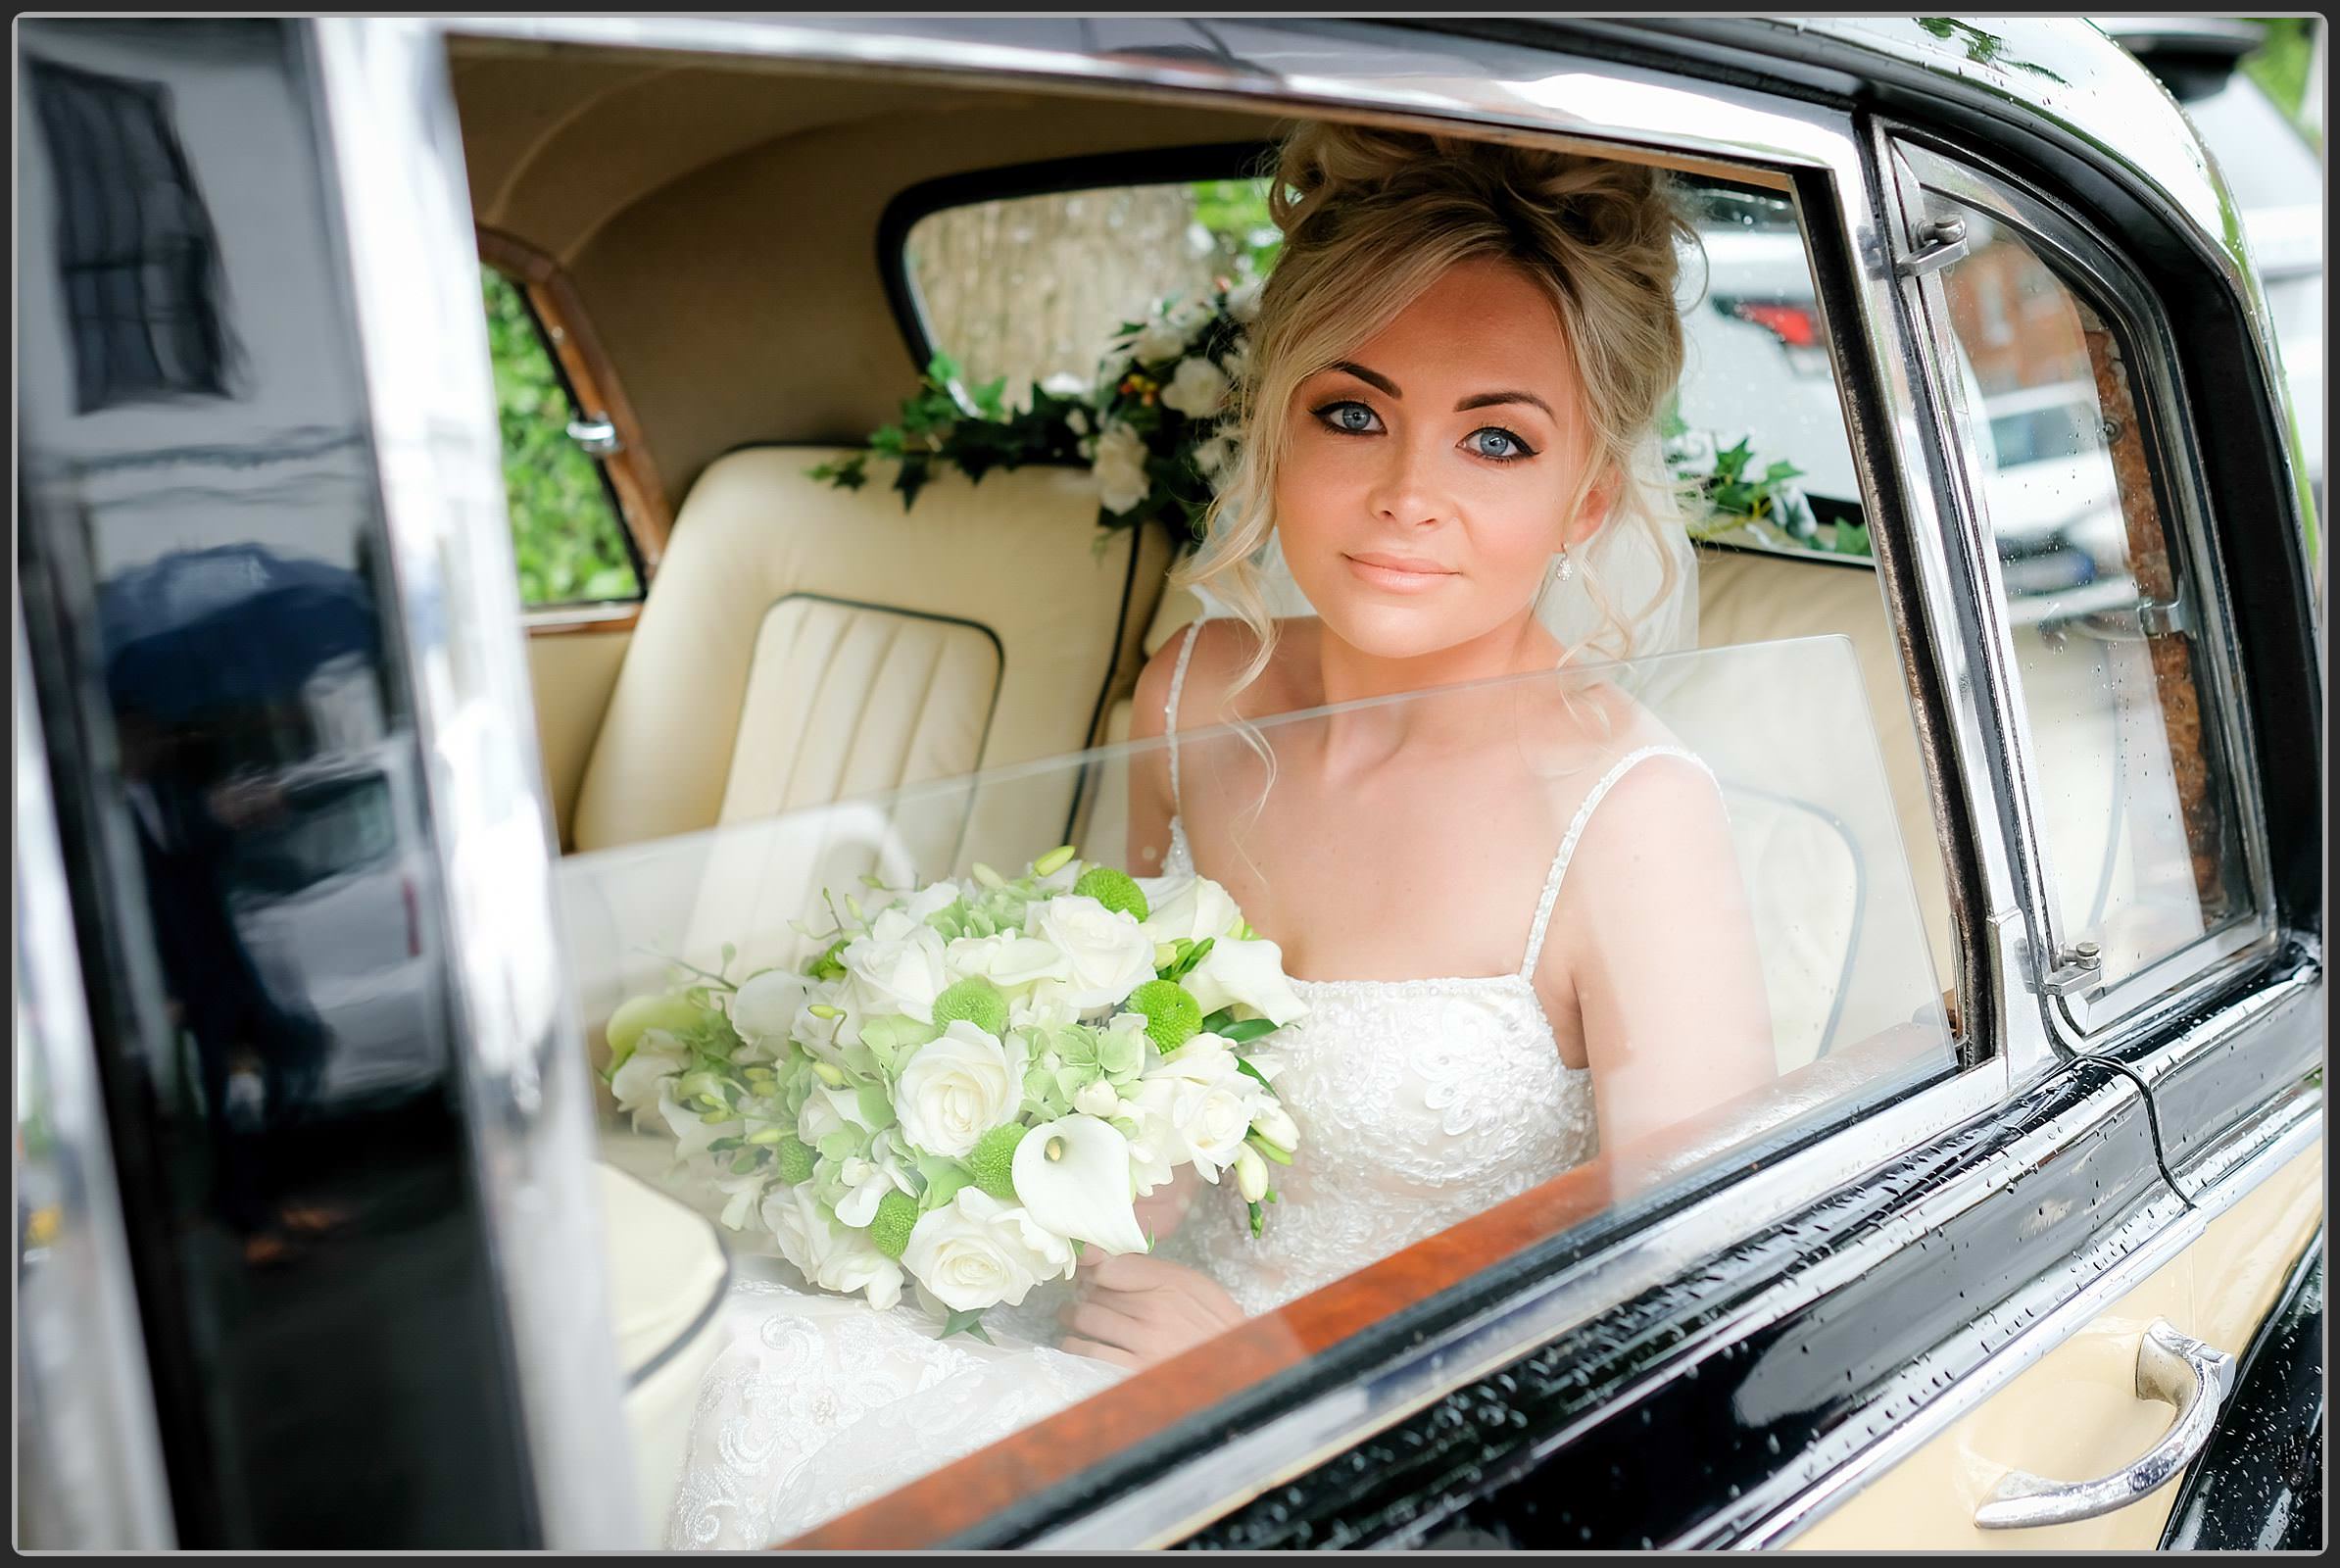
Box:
1942;204;2246;1005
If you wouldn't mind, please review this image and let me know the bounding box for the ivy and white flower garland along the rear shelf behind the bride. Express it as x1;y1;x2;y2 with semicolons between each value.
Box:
809;278;1870;555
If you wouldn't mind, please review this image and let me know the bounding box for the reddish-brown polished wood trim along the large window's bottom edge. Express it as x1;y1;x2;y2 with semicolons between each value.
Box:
774;1025;1947;1551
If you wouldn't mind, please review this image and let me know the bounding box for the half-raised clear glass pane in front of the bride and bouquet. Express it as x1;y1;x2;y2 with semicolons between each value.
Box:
557;637;1954;1544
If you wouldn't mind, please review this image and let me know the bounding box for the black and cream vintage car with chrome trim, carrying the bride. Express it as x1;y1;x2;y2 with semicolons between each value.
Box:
12;17;2326;1549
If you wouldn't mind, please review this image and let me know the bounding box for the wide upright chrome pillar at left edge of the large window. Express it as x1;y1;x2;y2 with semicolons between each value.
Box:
300;17;639;1549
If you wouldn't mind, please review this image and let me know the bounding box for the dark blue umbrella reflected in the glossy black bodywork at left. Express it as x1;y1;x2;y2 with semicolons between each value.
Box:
98;545;379;723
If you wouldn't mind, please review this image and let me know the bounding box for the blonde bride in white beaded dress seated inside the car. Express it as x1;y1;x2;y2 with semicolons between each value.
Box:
667;124;1774;1547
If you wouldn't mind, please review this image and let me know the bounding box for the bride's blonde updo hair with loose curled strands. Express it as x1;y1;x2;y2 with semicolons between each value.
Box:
1175;122;1694;688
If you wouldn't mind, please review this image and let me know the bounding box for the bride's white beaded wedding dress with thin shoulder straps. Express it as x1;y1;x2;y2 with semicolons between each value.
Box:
667;632;1706;1547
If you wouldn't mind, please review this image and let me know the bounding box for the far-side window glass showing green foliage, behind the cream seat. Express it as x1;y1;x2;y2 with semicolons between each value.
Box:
480;265;641;609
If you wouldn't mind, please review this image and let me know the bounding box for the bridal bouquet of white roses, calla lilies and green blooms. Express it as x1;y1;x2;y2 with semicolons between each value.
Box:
609;845;1303;1334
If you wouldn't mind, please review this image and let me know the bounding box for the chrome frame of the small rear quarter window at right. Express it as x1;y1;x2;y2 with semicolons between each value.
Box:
1879;134;2281;1065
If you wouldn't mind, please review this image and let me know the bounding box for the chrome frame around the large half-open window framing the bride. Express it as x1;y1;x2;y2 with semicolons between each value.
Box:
393;17;2077;1547
